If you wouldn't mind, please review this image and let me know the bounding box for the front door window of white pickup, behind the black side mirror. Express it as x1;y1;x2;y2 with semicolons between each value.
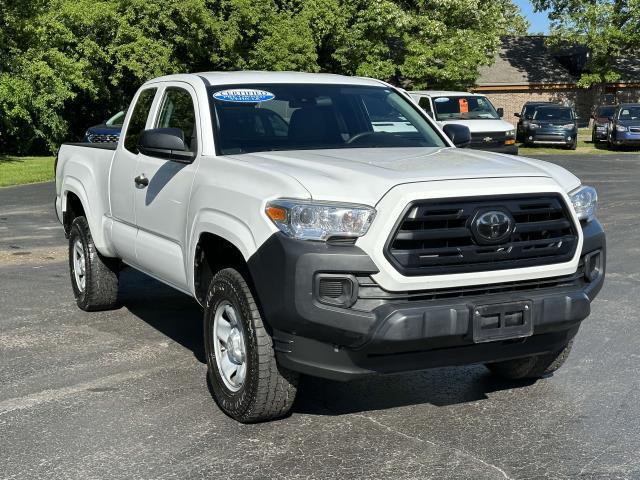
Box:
156;87;197;152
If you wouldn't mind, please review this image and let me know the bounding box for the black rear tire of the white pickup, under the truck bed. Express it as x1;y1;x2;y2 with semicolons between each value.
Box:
69;217;120;312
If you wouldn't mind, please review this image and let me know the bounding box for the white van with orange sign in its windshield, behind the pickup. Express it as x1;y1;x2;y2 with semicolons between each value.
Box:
408;91;518;155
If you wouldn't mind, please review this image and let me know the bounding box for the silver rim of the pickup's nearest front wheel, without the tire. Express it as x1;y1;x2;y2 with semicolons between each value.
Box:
212;300;247;392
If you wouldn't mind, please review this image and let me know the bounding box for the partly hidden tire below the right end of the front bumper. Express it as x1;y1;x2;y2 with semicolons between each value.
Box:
485;340;573;380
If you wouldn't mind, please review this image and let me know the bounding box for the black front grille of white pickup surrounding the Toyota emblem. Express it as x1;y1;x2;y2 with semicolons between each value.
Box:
385;194;578;275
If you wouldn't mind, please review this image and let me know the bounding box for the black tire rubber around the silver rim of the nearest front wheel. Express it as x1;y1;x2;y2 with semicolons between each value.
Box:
204;268;298;423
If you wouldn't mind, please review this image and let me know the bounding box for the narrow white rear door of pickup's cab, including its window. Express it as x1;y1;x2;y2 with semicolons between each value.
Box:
109;86;158;263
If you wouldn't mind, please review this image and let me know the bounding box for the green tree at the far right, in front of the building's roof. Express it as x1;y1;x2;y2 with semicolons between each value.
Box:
533;0;640;87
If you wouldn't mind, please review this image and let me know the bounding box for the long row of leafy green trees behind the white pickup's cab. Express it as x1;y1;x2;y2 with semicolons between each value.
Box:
0;0;527;153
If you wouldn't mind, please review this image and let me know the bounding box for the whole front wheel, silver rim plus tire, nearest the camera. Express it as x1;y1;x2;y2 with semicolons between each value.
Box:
204;268;298;423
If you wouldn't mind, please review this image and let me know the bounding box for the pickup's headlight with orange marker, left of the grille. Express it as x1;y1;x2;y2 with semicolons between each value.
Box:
265;199;376;241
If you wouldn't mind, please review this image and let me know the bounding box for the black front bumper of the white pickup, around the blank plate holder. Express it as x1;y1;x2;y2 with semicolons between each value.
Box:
249;221;605;380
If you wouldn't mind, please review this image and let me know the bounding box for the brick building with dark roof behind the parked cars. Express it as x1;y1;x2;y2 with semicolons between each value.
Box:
471;35;640;124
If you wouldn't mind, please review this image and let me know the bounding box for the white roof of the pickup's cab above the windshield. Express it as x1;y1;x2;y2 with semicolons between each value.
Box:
147;71;386;87
